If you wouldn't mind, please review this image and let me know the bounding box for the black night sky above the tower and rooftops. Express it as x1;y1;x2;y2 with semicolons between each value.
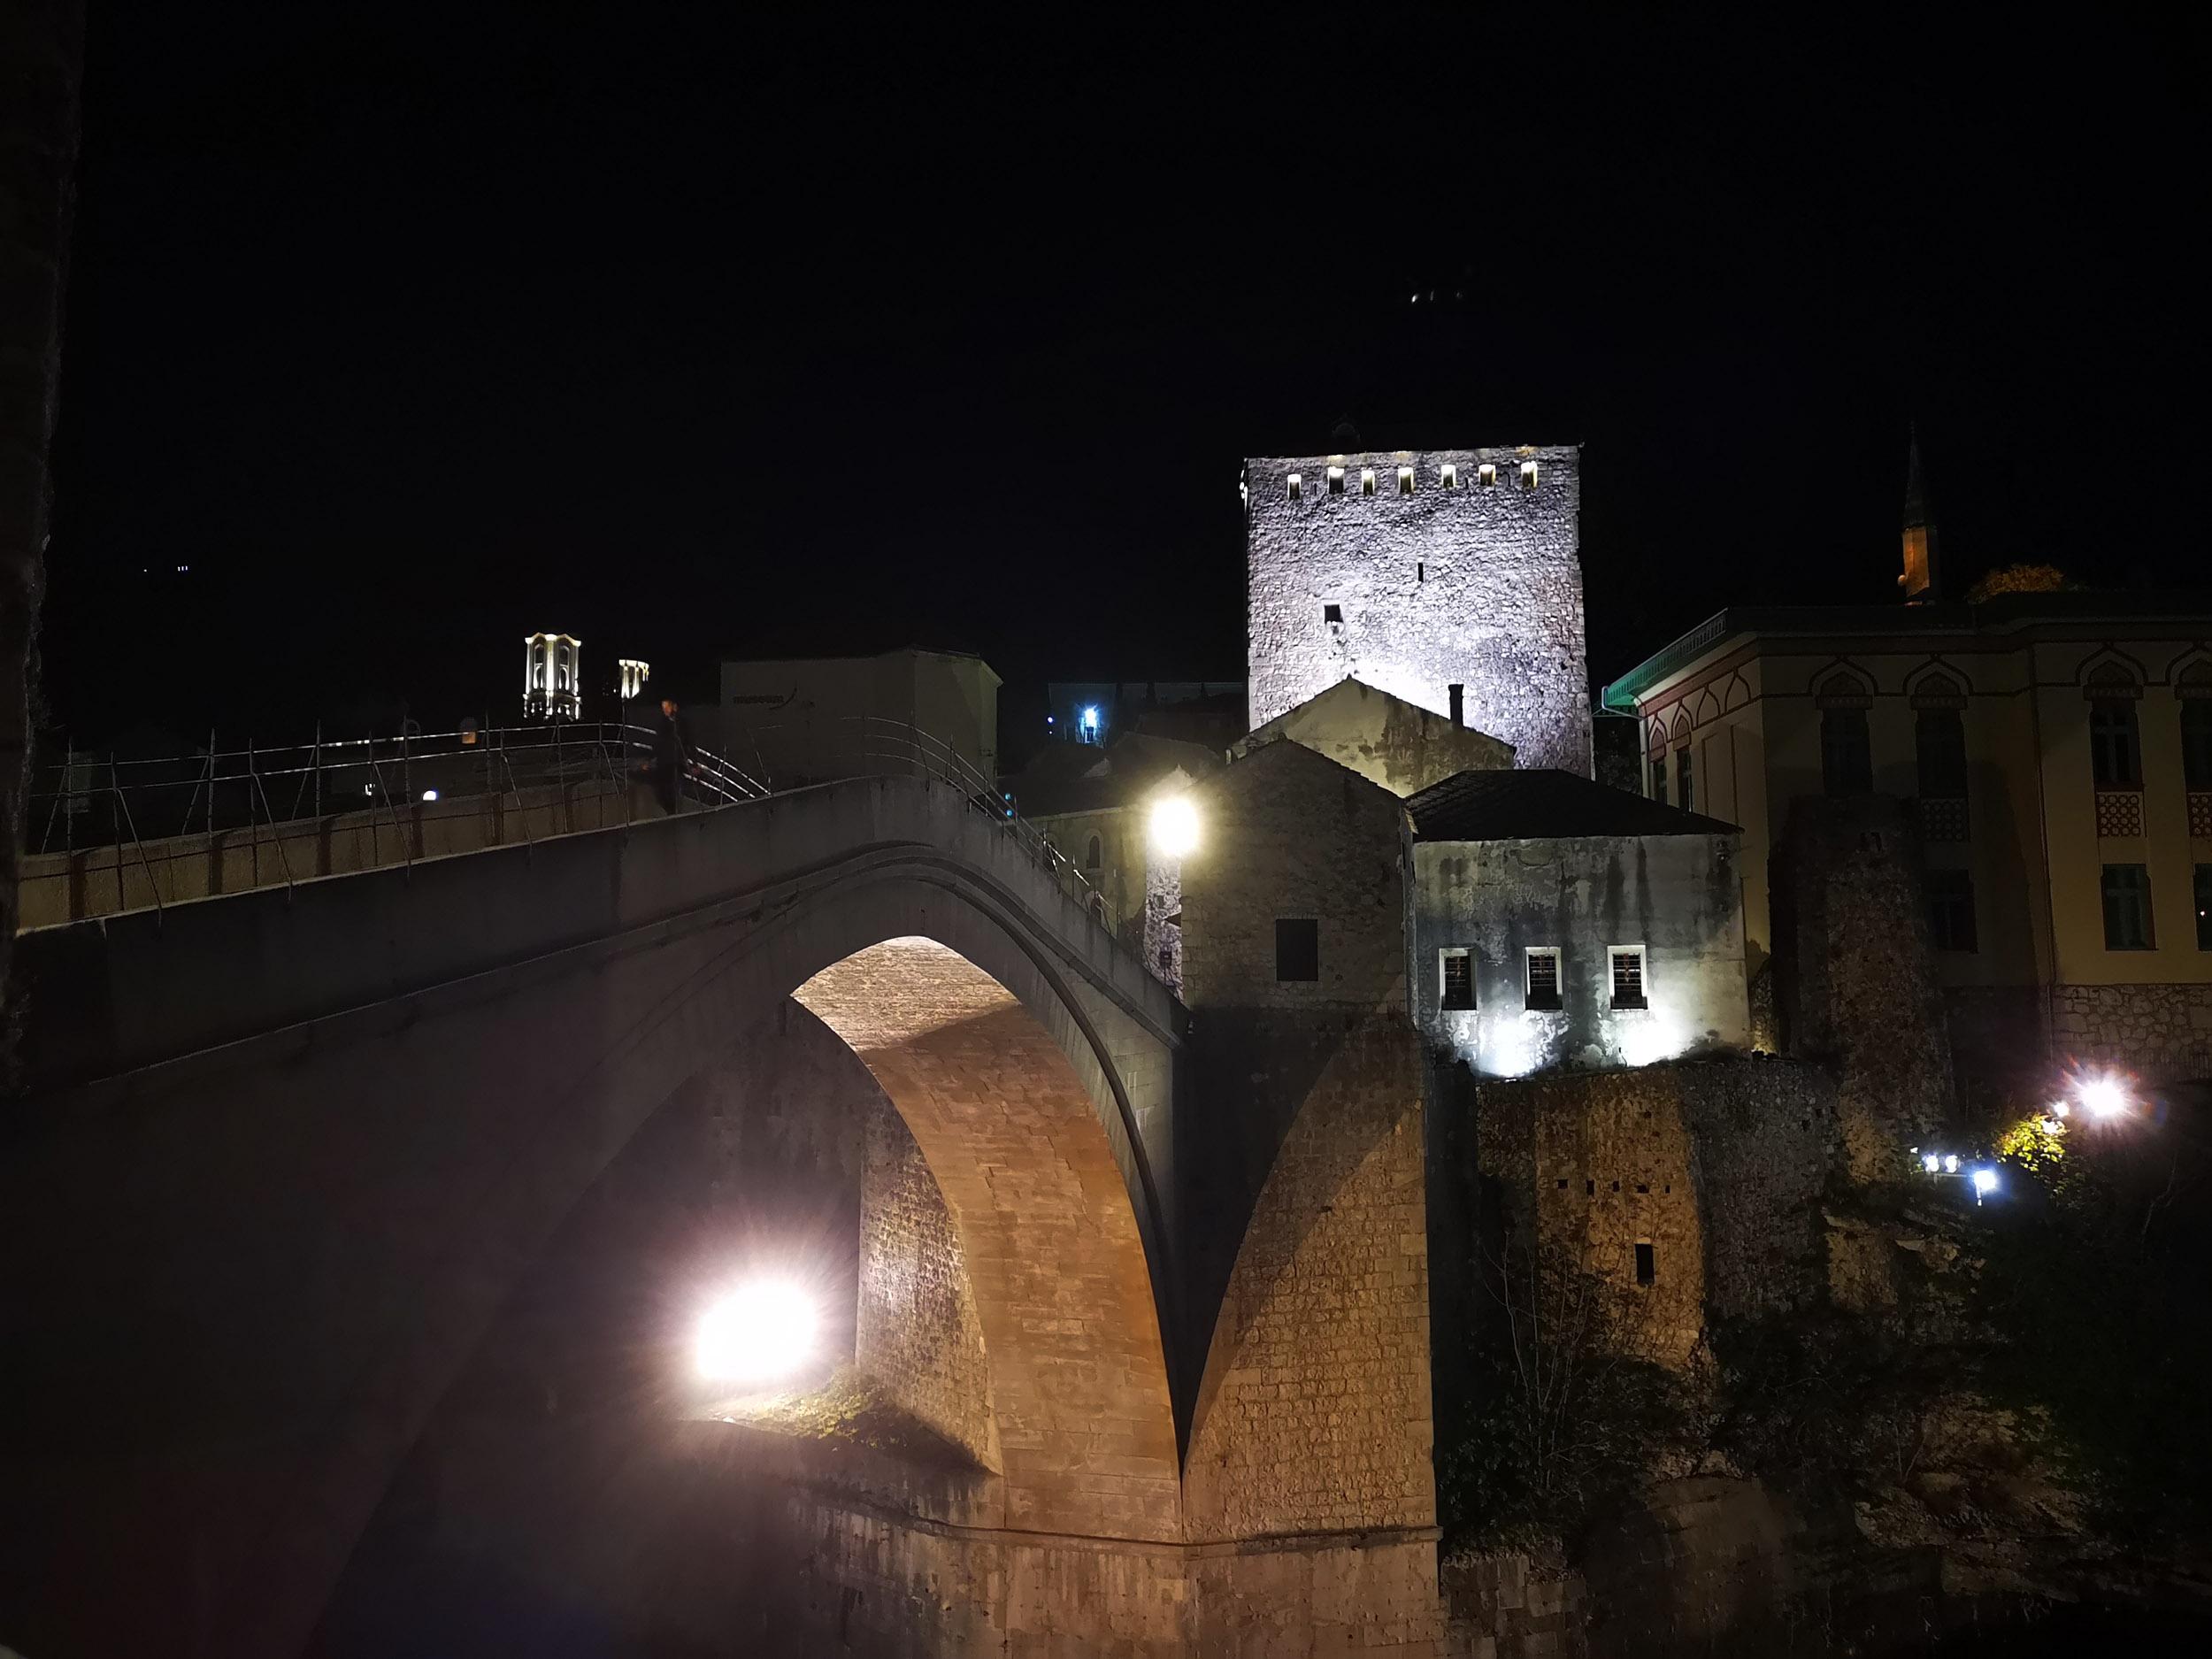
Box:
47;0;2208;743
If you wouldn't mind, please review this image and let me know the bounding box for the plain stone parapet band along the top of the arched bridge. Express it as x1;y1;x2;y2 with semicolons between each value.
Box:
18;779;1181;1087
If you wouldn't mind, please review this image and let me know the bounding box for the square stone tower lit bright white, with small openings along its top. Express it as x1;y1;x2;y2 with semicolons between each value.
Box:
1246;447;1591;777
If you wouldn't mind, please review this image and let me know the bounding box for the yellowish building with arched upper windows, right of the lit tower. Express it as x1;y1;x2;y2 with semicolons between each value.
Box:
1604;467;2212;1082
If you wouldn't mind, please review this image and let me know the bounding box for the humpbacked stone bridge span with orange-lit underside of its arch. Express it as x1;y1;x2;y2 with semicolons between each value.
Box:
0;779;1179;1655
